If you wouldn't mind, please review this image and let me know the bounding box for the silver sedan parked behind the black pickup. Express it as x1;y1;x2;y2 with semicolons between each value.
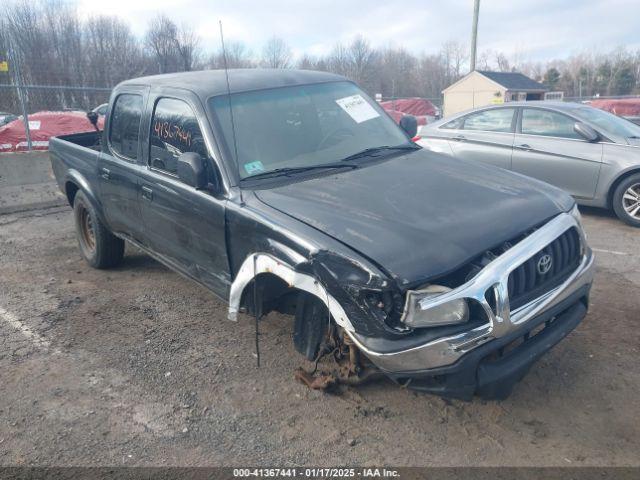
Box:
418;102;640;227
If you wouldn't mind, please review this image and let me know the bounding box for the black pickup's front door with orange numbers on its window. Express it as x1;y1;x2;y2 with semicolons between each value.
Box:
140;90;230;298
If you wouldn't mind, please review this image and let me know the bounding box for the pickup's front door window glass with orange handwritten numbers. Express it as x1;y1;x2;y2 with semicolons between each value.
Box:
149;98;208;175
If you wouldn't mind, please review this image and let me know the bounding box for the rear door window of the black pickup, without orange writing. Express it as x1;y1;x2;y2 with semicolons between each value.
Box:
109;93;142;161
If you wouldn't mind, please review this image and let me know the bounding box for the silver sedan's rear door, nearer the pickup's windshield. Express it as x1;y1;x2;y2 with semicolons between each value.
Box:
444;107;517;169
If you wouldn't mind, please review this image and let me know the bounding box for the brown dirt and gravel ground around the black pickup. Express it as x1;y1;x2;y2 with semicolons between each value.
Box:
0;203;640;466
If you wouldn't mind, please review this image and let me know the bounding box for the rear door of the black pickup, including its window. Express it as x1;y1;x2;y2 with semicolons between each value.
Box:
98;87;147;243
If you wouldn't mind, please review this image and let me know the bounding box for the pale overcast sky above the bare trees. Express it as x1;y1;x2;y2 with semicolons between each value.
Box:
79;0;640;61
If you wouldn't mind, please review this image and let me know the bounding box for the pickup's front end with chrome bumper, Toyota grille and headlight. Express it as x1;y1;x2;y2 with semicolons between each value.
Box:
348;208;594;400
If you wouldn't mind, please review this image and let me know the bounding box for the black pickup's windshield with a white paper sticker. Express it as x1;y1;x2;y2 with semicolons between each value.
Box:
209;82;411;179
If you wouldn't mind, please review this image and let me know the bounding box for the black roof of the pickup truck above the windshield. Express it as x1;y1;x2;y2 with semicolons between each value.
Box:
118;68;346;98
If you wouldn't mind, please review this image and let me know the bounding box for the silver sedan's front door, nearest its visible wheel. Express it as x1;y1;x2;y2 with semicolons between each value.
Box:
513;107;603;199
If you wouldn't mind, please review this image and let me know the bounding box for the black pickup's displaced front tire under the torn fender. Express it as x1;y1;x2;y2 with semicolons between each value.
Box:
293;292;329;361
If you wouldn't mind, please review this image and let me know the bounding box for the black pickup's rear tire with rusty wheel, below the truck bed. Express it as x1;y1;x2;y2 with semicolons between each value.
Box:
73;191;124;269
